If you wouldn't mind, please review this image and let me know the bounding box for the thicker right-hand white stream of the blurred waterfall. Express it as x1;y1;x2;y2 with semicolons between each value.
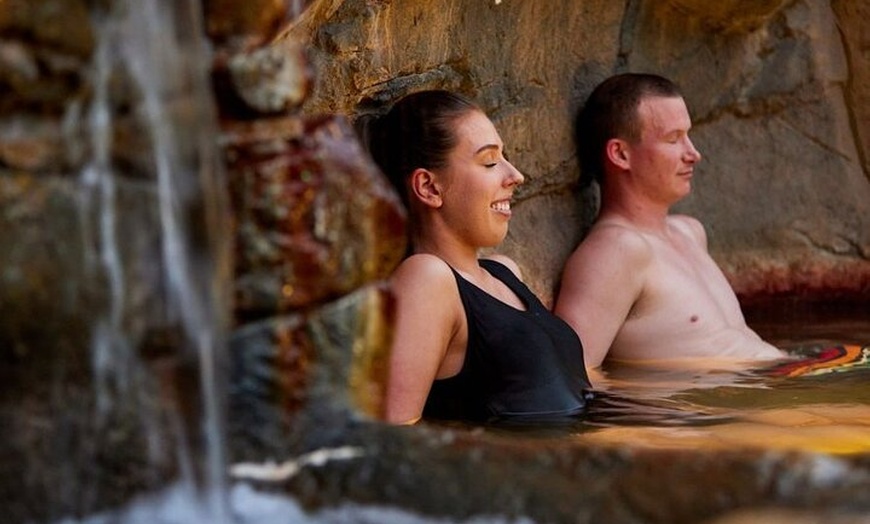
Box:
124;0;233;521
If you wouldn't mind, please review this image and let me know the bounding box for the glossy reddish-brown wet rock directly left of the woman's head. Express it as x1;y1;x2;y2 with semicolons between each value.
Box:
225;117;406;318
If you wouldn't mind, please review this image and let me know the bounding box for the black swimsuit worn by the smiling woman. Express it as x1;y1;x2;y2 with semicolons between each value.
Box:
423;260;590;422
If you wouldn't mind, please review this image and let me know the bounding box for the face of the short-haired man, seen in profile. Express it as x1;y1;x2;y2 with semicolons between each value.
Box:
628;96;701;206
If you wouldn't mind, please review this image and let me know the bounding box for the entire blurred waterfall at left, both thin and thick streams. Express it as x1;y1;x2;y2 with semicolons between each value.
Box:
72;0;230;523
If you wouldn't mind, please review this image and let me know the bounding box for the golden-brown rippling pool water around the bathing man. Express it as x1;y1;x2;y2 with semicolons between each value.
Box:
576;300;870;454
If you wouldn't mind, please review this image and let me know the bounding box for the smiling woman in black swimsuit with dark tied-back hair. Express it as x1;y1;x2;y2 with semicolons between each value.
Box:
365;91;589;423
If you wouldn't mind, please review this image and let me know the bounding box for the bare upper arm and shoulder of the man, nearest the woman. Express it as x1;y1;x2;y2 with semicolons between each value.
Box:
554;226;652;369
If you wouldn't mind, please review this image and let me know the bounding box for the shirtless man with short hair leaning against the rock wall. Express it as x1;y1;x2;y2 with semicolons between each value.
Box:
555;74;785;369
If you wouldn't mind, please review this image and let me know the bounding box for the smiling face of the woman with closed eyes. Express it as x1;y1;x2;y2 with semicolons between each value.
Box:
436;111;523;248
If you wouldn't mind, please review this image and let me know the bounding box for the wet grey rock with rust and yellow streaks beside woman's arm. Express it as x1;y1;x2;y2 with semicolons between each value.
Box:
229;284;393;461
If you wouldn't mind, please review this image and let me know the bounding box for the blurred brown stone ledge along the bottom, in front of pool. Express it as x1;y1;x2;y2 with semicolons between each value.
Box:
242;425;870;524
